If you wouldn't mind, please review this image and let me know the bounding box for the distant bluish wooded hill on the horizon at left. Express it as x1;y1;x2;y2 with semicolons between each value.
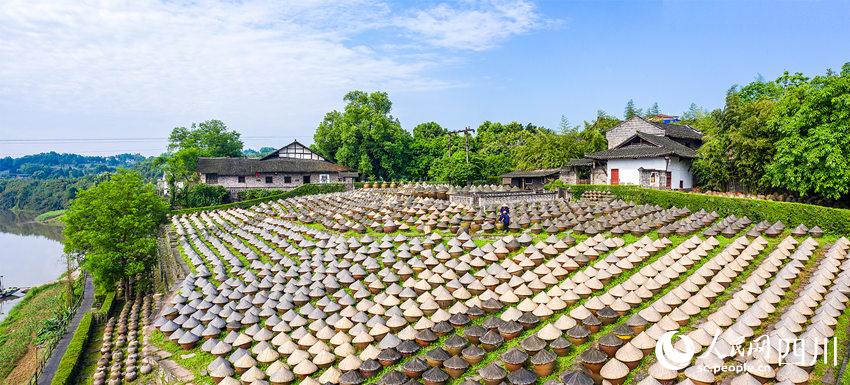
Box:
0;152;145;180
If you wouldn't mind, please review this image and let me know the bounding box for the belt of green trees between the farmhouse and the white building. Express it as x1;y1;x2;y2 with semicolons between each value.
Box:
312;91;608;184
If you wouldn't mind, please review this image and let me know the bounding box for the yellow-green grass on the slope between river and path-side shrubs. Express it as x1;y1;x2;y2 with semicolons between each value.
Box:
0;282;71;384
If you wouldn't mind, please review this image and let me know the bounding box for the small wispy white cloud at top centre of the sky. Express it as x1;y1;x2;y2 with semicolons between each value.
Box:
394;0;546;51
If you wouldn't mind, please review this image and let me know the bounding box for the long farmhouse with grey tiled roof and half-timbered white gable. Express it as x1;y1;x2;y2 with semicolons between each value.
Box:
198;141;358;192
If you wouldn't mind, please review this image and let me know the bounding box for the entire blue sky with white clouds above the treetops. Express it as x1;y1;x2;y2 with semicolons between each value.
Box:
0;0;850;156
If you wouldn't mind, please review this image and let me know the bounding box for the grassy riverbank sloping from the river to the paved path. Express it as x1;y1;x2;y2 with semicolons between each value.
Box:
0;280;82;384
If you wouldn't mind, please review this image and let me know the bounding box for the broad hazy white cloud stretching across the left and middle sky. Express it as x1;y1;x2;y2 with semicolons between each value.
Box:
0;0;540;137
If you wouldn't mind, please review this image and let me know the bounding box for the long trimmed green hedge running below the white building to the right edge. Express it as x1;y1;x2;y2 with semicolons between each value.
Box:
568;185;850;235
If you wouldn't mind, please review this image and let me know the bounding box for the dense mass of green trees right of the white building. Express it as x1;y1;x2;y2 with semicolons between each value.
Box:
685;63;850;199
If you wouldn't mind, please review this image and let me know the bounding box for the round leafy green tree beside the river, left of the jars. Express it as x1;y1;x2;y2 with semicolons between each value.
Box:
64;169;168;298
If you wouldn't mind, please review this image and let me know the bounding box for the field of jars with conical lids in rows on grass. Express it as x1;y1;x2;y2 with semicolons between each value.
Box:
147;189;850;385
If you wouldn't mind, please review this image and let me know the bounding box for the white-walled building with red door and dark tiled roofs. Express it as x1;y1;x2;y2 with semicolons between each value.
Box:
561;117;702;190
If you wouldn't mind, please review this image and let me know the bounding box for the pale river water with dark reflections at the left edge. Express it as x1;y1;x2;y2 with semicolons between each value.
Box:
0;211;65;320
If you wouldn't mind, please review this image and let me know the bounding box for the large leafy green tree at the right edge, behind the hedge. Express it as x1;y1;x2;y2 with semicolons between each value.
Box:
766;63;850;199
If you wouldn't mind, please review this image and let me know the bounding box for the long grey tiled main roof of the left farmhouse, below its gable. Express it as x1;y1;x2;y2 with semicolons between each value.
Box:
198;158;351;175
